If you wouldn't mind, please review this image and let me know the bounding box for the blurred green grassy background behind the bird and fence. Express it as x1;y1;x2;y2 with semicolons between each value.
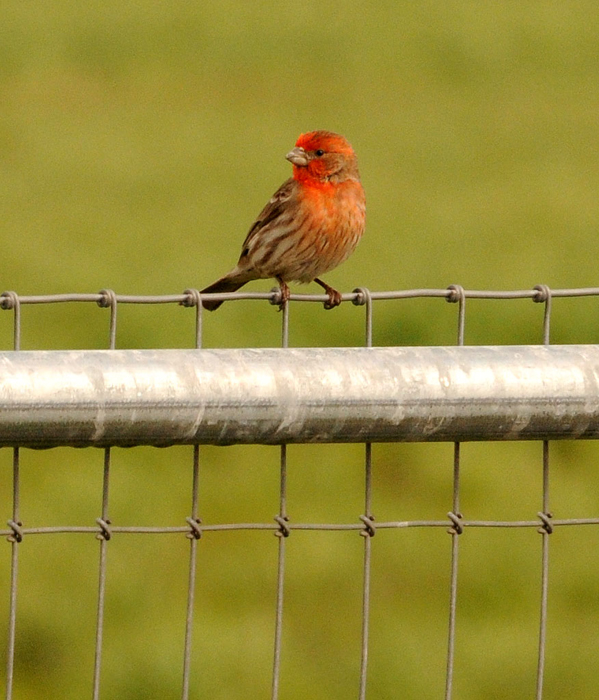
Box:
0;0;599;700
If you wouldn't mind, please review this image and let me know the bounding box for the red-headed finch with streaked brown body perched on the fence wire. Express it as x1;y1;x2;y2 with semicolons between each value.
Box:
201;131;366;311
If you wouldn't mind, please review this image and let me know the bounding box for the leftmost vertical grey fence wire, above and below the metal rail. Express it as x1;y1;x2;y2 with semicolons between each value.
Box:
2;292;23;700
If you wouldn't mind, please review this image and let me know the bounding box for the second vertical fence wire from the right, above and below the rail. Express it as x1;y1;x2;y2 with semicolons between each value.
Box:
445;285;466;700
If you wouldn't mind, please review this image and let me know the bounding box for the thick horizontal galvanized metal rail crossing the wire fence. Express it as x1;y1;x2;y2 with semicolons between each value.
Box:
0;345;599;447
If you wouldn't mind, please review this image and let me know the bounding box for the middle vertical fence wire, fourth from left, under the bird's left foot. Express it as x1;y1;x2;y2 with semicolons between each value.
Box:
271;301;289;700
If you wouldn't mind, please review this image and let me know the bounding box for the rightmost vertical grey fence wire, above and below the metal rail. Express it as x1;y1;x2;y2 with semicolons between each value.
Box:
533;285;553;700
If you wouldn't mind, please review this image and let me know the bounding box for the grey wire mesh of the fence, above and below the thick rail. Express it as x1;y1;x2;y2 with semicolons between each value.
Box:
0;285;599;700
